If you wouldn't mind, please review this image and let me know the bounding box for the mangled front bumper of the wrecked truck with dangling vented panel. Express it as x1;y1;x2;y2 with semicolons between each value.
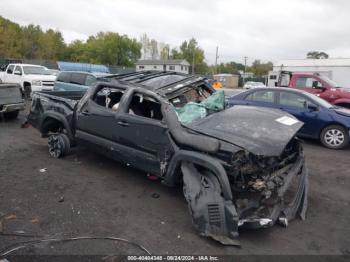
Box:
181;156;308;245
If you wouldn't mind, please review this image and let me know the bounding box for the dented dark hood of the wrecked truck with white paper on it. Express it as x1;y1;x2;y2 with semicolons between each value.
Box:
187;106;303;156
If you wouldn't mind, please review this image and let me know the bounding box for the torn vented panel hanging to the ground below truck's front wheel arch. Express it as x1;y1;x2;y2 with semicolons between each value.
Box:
181;161;240;246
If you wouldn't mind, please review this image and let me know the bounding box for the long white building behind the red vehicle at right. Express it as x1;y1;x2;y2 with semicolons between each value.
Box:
269;58;350;87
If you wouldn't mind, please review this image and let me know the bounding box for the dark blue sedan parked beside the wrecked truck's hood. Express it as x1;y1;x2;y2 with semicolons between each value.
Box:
228;87;350;149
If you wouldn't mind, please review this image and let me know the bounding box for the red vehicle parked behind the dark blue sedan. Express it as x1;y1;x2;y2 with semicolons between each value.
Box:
277;71;350;108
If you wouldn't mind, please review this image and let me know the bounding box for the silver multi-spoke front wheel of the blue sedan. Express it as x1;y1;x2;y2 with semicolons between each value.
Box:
320;125;349;149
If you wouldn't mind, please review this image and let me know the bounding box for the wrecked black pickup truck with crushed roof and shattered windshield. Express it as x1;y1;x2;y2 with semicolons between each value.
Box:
28;73;308;245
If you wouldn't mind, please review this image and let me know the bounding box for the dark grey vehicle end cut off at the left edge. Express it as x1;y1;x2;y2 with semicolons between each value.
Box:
0;84;25;119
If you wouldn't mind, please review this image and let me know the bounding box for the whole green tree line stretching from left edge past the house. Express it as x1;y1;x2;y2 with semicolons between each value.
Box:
0;16;272;76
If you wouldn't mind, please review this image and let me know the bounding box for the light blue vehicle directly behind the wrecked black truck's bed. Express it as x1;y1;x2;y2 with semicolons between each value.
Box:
53;71;109;91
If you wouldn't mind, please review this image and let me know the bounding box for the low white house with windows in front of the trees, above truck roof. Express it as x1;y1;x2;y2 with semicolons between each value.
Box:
136;59;190;74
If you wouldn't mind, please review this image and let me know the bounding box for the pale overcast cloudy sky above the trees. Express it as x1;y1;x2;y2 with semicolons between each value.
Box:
0;0;350;63
